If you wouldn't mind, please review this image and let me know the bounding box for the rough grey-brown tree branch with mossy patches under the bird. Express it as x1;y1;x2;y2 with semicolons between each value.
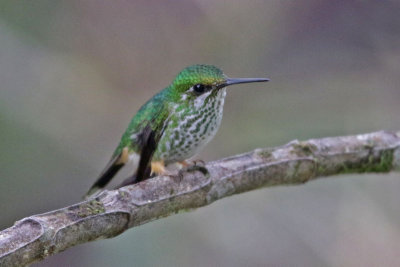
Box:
0;132;400;266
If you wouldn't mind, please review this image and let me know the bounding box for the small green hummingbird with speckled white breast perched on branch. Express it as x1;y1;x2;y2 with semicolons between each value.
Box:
87;65;269;196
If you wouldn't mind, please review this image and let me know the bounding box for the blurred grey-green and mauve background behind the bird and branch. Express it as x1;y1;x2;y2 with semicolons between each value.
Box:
0;0;400;266
